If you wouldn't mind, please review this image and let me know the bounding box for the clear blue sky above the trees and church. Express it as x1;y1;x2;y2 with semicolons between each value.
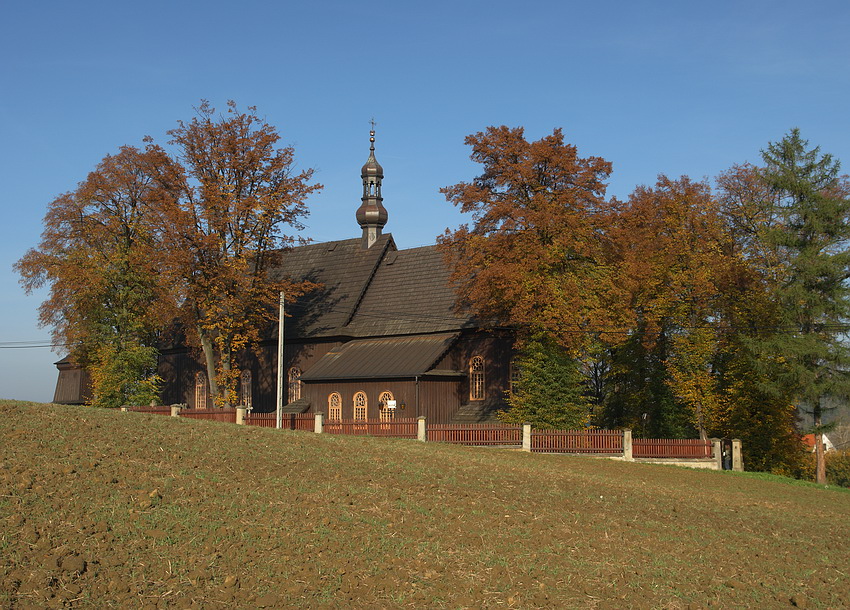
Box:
0;0;850;401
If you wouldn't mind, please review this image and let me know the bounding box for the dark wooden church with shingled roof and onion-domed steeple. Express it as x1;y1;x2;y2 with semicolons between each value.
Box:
57;131;513;423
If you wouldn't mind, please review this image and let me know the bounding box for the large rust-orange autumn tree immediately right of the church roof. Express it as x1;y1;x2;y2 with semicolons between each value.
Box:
439;126;618;422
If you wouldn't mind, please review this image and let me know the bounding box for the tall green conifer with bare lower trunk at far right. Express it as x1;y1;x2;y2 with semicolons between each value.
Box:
754;129;850;483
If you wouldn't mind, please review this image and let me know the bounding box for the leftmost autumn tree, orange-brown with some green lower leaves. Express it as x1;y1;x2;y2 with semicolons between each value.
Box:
15;144;176;407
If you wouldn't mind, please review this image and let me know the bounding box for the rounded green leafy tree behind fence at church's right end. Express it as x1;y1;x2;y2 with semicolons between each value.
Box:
499;333;591;430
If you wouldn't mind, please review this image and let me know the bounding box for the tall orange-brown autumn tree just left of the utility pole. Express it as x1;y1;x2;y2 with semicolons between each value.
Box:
160;101;321;405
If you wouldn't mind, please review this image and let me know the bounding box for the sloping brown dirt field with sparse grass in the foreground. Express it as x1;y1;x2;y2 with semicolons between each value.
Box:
0;401;850;608
